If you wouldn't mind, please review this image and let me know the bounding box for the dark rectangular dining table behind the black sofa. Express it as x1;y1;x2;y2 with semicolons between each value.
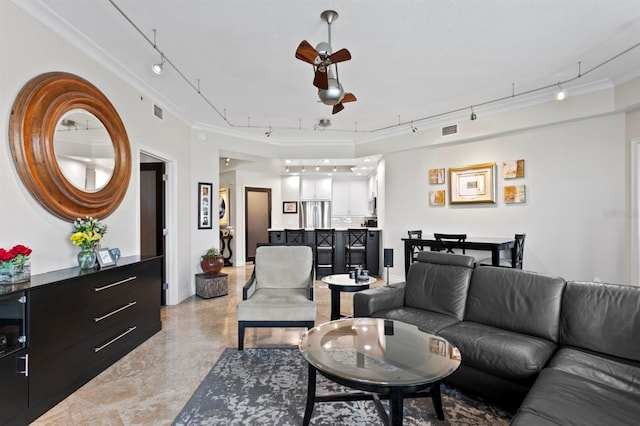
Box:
402;236;516;277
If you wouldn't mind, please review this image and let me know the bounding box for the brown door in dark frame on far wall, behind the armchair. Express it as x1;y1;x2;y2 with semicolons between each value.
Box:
244;188;271;262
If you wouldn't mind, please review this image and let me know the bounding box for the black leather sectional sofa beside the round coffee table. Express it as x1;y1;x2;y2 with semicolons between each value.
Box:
353;252;640;425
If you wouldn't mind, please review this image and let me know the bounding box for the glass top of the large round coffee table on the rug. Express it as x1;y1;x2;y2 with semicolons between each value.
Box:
299;318;461;386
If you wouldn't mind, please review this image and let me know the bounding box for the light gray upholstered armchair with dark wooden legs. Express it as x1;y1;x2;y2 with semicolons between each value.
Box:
236;246;316;350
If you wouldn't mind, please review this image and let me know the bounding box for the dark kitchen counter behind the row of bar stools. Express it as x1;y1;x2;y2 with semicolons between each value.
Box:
268;227;381;279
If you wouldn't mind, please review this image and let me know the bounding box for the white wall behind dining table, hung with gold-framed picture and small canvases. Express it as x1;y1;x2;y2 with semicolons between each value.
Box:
384;114;628;283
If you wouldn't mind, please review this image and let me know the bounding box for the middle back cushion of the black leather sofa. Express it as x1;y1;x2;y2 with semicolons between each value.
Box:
464;266;565;342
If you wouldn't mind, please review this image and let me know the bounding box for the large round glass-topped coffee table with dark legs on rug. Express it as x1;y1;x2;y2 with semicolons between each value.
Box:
299;318;461;425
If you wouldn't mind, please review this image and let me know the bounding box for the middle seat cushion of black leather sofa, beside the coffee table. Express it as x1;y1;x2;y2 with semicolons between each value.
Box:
439;322;556;380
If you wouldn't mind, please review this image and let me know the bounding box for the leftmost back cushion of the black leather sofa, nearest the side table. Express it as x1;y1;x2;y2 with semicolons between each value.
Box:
404;251;474;320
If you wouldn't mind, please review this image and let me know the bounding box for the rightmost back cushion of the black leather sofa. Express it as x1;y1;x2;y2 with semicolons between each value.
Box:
560;281;640;361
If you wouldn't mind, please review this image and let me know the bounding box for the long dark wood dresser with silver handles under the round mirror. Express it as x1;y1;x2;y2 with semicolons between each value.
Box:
0;256;162;424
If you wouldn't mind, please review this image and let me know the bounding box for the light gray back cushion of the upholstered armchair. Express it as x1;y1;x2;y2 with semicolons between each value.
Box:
255;246;313;288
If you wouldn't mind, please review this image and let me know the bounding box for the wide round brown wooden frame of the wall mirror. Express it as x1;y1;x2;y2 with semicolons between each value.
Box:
9;72;131;221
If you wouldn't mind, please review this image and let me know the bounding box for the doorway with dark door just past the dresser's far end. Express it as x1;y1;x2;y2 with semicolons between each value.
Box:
140;161;167;305
